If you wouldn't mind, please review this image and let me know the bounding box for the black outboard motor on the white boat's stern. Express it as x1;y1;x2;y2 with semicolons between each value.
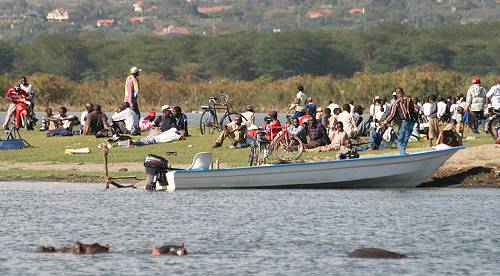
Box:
144;154;168;191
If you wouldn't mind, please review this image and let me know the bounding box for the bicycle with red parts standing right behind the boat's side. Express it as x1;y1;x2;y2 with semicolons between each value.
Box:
248;116;304;166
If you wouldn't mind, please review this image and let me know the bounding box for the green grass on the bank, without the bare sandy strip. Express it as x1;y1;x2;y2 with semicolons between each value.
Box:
0;128;493;180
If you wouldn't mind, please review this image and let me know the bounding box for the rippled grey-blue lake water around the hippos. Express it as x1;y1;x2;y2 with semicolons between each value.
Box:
0;182;500;275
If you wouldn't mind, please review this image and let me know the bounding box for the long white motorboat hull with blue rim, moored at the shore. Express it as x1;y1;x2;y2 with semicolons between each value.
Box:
156;147;464;191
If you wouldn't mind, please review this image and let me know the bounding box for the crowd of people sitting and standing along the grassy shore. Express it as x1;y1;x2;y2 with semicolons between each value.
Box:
3;67;500;154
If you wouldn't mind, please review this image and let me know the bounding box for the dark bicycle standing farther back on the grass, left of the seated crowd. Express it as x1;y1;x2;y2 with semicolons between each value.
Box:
200;94;247;135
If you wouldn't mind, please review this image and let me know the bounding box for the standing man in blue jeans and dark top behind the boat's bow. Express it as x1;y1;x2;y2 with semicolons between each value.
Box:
384;87;418;155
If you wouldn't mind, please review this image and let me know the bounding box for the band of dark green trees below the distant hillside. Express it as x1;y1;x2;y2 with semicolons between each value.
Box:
0;21;500;82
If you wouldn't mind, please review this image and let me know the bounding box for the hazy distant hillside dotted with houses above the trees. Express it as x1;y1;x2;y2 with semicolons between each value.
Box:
0;0;500;42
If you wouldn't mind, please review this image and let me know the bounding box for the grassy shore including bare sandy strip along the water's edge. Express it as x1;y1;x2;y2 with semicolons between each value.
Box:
0;128;492;183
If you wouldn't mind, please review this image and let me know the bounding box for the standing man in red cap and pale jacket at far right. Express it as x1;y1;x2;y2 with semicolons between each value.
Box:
465;77;486;134
